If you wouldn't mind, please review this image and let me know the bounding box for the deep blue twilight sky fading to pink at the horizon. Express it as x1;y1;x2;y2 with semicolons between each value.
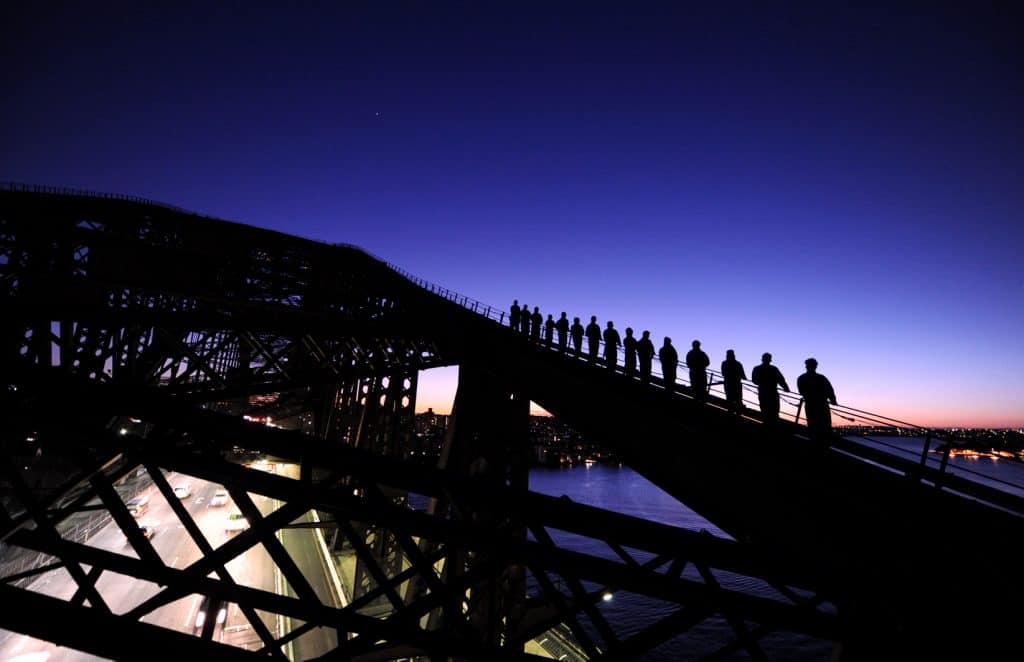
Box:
0;2;1024;426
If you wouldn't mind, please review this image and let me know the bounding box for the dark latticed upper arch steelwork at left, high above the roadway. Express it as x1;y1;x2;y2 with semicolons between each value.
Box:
0;191;443;401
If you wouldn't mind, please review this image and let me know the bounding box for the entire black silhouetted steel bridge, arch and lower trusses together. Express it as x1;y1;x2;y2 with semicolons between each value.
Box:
0;185;1024;660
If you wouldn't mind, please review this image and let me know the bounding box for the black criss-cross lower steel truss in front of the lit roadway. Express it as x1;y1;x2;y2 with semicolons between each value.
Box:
3;368;838;659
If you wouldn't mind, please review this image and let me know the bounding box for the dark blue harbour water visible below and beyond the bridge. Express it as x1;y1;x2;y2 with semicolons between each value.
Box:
530;438;1024;662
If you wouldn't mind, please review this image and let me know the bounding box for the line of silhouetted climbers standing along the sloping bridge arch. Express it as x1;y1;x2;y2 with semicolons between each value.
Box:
509;299;838;440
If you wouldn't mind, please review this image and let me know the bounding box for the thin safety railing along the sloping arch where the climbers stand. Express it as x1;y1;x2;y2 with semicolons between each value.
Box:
381;260;1024;515
